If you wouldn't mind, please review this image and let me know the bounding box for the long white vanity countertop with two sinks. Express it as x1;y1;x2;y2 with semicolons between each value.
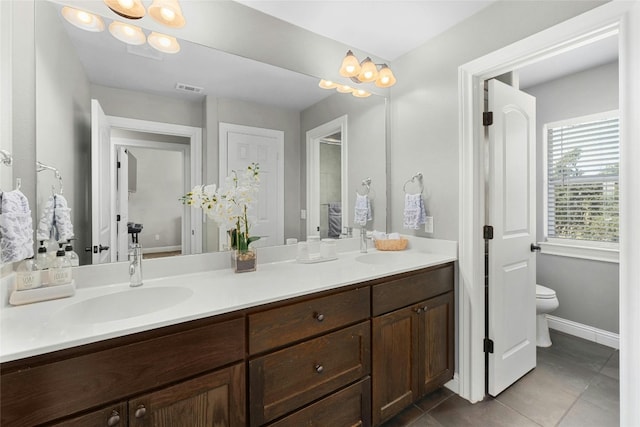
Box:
0;238;457;362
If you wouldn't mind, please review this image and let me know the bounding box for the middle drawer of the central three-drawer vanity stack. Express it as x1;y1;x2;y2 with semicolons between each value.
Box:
249;321;371;426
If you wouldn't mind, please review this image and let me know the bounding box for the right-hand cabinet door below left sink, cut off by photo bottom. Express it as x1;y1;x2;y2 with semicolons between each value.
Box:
129;363;245;427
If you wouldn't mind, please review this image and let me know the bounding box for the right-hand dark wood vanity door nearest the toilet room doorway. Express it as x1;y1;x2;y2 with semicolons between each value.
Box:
418;292;454;396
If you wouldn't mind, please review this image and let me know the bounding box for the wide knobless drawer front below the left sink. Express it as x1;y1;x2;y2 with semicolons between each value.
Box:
0;318;245;426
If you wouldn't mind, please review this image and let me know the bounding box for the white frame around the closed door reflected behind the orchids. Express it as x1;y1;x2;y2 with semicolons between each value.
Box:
218;122;285;250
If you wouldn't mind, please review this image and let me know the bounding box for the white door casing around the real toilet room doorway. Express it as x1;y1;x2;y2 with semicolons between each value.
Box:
459;4;639;421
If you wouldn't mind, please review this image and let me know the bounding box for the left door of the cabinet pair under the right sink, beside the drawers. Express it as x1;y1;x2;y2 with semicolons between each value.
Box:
371;305;420;425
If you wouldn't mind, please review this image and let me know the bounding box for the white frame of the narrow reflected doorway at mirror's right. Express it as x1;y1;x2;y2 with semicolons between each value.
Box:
306;114;349;236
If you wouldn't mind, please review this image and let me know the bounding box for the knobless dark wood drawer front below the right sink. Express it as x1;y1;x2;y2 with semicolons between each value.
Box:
371;263;453;316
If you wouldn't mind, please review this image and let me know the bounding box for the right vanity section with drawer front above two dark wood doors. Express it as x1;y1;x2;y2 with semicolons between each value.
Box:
371;269;454;425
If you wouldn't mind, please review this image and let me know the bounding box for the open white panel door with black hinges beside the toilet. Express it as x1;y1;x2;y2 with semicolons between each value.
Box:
488;80;536;396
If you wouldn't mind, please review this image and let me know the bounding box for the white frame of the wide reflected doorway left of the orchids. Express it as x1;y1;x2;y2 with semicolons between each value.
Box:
107;116;202;254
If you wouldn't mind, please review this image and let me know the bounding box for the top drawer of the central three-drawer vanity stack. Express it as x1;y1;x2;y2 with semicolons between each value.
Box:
249;287;370;354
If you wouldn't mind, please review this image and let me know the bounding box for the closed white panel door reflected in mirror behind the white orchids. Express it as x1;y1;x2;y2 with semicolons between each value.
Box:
220;123;284;247
